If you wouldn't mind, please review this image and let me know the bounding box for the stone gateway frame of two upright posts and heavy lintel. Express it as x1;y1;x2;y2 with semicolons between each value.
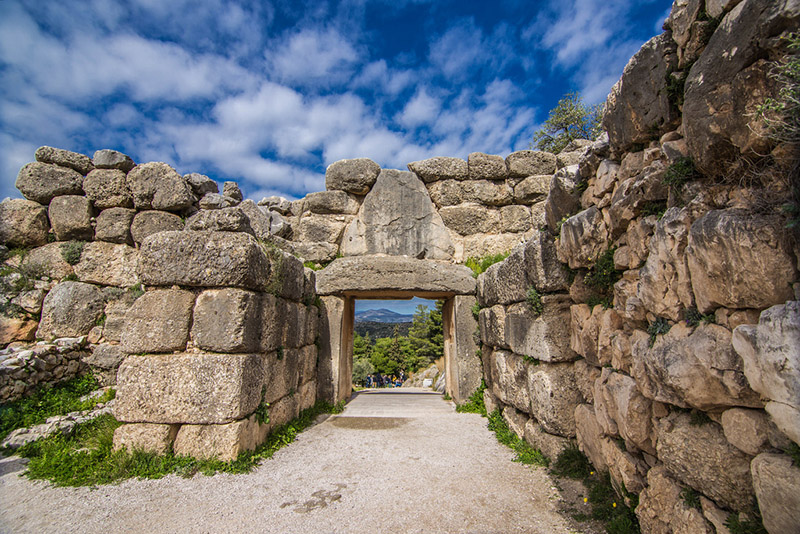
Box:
317;256;481;402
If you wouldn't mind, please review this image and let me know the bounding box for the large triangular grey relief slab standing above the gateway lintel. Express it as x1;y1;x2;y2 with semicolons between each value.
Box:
341;170;454;260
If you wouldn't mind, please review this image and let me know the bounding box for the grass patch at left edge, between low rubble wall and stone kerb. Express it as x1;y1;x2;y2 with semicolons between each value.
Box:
0;374;108;441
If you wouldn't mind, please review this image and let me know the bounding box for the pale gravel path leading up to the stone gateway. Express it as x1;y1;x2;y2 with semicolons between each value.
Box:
0;389;588;534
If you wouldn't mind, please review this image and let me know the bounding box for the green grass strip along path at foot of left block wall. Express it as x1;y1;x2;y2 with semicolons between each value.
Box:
18;403;344;486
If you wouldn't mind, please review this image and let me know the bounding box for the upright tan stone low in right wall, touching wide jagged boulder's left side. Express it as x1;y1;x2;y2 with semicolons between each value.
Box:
594;367;656;455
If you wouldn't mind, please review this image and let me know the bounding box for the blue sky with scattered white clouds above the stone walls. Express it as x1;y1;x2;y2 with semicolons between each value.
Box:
0;0;671;200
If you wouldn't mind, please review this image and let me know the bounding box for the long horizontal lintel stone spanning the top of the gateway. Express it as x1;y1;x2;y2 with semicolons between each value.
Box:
317;256;475;295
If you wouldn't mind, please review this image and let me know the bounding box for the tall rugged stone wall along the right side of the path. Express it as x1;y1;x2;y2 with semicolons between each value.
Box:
478;0;800;534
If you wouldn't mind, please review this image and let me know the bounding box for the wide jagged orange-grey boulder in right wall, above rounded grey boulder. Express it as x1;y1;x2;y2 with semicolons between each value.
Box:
632;323;762;411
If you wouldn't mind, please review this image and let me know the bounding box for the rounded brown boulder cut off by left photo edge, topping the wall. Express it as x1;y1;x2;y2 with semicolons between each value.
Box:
0;198;50;248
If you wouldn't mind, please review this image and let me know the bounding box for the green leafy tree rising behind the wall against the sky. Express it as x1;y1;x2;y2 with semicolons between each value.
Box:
531;93;603;154
